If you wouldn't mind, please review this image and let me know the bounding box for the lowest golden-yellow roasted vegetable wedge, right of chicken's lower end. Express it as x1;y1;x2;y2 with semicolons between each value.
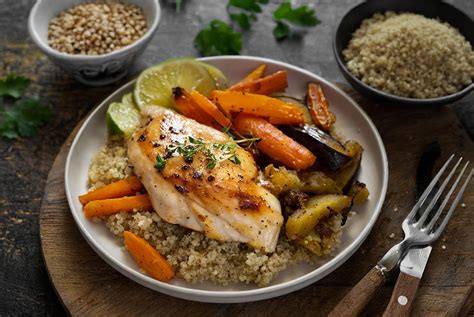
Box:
286;195;352;240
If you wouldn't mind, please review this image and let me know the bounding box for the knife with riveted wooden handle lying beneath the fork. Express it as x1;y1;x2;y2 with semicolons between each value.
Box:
383;142;441;317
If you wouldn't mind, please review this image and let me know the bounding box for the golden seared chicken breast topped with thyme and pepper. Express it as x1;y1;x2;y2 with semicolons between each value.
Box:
128;107;283;252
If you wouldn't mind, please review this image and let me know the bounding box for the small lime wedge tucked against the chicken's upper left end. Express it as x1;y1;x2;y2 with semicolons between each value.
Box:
106;94;140;137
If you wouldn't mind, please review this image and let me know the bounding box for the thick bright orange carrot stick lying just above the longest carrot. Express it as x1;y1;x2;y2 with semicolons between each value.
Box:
211;90;304;124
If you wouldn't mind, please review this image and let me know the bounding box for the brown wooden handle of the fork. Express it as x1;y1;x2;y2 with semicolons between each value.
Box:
329;267;385;317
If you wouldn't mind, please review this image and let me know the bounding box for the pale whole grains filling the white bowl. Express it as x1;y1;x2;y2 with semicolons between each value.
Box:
48;1;147;55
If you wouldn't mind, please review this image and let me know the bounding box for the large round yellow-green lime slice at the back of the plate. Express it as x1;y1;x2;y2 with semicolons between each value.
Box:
133;58;217;109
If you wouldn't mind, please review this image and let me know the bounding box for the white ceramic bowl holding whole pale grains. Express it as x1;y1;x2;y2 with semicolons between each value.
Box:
28;0;161;86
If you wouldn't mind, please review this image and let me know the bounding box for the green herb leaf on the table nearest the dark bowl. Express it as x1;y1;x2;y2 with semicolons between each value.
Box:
273;1;320;41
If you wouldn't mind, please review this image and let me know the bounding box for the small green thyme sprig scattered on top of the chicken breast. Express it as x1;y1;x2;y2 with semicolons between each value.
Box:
155;136;260;172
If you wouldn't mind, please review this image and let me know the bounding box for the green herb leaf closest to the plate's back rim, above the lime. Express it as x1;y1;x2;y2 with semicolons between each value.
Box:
194;20;242;56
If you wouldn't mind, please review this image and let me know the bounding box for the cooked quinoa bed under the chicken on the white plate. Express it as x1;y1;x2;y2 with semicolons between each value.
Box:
89;140;342;286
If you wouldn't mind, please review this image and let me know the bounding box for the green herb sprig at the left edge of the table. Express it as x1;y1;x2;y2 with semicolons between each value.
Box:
0;74;51;139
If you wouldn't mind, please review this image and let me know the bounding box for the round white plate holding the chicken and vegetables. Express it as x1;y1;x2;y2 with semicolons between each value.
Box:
65;56;388;303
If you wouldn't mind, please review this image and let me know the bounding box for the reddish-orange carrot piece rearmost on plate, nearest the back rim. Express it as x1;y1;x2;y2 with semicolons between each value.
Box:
229;70;288;95
